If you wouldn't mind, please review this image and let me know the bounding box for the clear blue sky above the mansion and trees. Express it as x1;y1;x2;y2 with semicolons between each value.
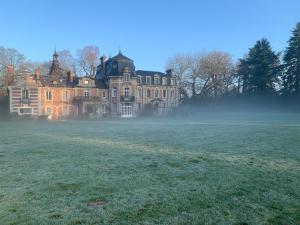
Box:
0;0;300;70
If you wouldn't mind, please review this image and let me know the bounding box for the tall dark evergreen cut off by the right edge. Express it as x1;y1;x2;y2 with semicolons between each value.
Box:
283;23;300;96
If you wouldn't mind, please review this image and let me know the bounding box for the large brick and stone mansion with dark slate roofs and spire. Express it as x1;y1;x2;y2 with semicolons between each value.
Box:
9;50;178;119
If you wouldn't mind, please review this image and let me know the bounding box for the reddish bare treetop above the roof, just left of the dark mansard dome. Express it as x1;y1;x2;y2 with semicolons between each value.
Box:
77;46;99;77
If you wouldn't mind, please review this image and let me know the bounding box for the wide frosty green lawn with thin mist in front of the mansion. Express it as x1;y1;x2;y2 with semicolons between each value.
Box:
0;114;300;225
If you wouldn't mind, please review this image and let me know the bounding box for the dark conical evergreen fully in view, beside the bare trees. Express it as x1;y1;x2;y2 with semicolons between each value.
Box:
239;39;280;94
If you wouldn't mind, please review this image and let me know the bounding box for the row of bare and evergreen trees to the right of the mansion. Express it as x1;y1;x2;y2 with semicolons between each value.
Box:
167;23;300;105
